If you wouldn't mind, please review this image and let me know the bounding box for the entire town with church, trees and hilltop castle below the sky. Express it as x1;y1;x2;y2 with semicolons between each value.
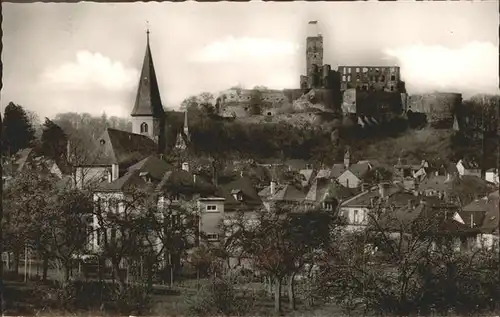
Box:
2;8;500;316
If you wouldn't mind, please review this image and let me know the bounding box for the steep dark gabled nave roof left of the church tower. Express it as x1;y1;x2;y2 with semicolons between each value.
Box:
95;128;158;165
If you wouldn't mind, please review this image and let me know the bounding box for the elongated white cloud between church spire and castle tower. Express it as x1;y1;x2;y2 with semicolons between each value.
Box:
191;36;299;63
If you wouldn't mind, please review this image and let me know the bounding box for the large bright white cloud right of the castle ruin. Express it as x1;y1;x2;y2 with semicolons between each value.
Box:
384;42;499;93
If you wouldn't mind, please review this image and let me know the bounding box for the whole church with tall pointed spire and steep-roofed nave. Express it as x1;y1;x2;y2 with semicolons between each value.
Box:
74;30;191;188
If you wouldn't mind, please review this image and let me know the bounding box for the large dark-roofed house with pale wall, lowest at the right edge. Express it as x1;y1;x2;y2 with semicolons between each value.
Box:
460;190;499;248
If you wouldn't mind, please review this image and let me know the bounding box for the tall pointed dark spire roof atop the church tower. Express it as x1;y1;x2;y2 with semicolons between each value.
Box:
131;31;165;118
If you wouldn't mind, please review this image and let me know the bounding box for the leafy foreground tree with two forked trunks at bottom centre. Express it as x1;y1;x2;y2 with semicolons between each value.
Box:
229;205;335;314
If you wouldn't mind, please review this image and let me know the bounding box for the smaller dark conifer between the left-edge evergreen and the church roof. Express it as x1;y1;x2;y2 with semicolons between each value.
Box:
41;118;68;162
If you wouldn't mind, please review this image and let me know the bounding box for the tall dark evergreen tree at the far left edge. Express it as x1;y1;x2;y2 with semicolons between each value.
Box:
3;102;35;155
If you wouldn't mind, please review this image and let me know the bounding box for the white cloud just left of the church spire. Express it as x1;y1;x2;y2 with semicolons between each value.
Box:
42;51;139;91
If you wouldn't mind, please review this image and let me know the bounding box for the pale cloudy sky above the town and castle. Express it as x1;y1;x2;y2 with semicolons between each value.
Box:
1;1;499;118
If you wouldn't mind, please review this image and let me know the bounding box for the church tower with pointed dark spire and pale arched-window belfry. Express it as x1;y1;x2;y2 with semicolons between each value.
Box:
130;29;165;145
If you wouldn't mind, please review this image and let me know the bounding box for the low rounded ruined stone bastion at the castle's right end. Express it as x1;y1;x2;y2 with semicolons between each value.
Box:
406;92;462;128
